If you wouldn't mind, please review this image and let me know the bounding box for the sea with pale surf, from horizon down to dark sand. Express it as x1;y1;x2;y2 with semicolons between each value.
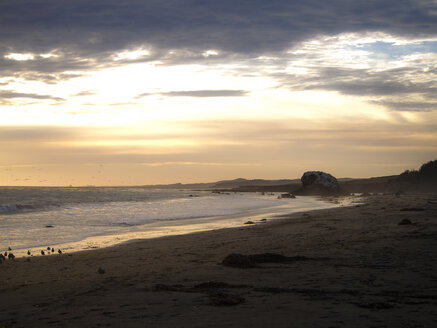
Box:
0;187;350;256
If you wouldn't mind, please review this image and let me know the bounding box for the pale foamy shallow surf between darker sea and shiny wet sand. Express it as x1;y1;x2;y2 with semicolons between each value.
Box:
0;193;280;249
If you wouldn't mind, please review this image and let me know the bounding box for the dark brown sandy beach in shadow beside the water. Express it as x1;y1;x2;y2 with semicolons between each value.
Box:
0;194;437;327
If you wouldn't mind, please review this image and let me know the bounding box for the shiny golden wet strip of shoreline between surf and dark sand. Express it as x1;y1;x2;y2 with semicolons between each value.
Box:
5;196;354;258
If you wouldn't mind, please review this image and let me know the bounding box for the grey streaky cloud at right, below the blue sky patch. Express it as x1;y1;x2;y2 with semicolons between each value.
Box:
272;67;437;111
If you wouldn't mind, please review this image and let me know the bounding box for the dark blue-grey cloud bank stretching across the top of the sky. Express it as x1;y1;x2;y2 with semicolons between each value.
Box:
0;0;437;78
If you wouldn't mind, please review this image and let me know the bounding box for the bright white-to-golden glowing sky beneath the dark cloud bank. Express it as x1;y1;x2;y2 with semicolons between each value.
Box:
0;28;437;185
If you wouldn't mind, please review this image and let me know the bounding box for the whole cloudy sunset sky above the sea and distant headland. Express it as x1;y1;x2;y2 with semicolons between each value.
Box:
0;0;437;186
